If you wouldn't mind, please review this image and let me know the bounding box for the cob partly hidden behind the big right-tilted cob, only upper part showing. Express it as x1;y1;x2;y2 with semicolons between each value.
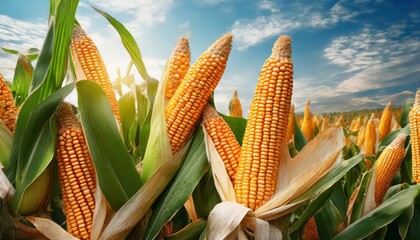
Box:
165;37;191;99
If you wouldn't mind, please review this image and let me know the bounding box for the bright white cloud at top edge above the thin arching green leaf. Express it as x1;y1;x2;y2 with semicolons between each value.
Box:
92;0;173;27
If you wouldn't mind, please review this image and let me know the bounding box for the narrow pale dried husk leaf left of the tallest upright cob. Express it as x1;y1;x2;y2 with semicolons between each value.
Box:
202;125;236;202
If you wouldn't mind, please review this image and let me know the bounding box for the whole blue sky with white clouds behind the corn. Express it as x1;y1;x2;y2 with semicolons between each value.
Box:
0;0;420;116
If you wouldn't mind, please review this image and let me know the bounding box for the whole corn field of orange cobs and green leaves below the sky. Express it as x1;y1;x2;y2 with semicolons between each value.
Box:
0;0;420;240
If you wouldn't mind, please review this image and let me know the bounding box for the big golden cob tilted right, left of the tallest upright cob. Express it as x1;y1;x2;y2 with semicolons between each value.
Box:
166;33;232;153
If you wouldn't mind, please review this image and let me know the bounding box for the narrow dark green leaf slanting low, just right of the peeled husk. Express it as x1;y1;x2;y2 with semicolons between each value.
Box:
289;184;335;233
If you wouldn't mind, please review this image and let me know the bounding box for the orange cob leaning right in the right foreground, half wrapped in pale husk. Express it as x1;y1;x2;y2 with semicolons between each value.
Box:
375;134;407;205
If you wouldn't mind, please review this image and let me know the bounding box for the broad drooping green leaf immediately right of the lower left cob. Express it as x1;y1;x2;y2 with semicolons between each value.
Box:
76;80;141;211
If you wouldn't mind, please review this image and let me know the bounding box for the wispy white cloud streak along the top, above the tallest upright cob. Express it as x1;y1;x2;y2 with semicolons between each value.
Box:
232;0;372;49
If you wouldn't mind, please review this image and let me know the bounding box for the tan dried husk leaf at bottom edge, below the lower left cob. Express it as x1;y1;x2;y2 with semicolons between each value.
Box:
26;217;78;240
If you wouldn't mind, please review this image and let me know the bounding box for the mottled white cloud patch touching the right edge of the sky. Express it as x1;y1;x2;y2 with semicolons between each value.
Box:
324;24;420;92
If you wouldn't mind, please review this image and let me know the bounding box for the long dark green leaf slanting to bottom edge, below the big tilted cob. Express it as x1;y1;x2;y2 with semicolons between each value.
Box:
144;128;209;239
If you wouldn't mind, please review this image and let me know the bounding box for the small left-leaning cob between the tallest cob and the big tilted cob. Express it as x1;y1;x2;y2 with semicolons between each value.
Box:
202;105;241;183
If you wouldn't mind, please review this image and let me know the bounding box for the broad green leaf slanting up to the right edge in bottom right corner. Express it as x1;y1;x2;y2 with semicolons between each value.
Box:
333;185;420;240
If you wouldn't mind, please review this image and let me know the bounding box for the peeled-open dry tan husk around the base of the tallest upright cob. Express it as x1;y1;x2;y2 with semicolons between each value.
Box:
204;127;345;239
